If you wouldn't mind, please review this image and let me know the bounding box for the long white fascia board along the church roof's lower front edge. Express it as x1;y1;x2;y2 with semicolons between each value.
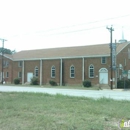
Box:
13;55;110;61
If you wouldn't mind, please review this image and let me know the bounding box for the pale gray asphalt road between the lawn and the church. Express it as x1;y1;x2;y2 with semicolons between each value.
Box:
0;85;130;100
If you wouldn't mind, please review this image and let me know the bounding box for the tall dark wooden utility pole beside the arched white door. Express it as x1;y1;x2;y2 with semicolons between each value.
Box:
107;26;114;89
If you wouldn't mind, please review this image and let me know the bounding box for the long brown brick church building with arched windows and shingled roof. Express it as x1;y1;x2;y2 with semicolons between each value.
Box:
0;42;130;86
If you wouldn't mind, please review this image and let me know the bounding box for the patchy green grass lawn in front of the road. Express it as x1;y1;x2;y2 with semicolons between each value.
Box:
0;92;130;130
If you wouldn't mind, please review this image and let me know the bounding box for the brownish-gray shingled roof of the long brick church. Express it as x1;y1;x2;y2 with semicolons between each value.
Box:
4;43;129;60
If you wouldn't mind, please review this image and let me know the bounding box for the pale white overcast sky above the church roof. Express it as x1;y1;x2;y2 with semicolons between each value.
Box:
0;0;130;52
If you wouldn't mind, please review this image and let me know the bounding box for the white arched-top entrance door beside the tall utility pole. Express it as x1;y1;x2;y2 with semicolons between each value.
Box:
99;68;108;84
